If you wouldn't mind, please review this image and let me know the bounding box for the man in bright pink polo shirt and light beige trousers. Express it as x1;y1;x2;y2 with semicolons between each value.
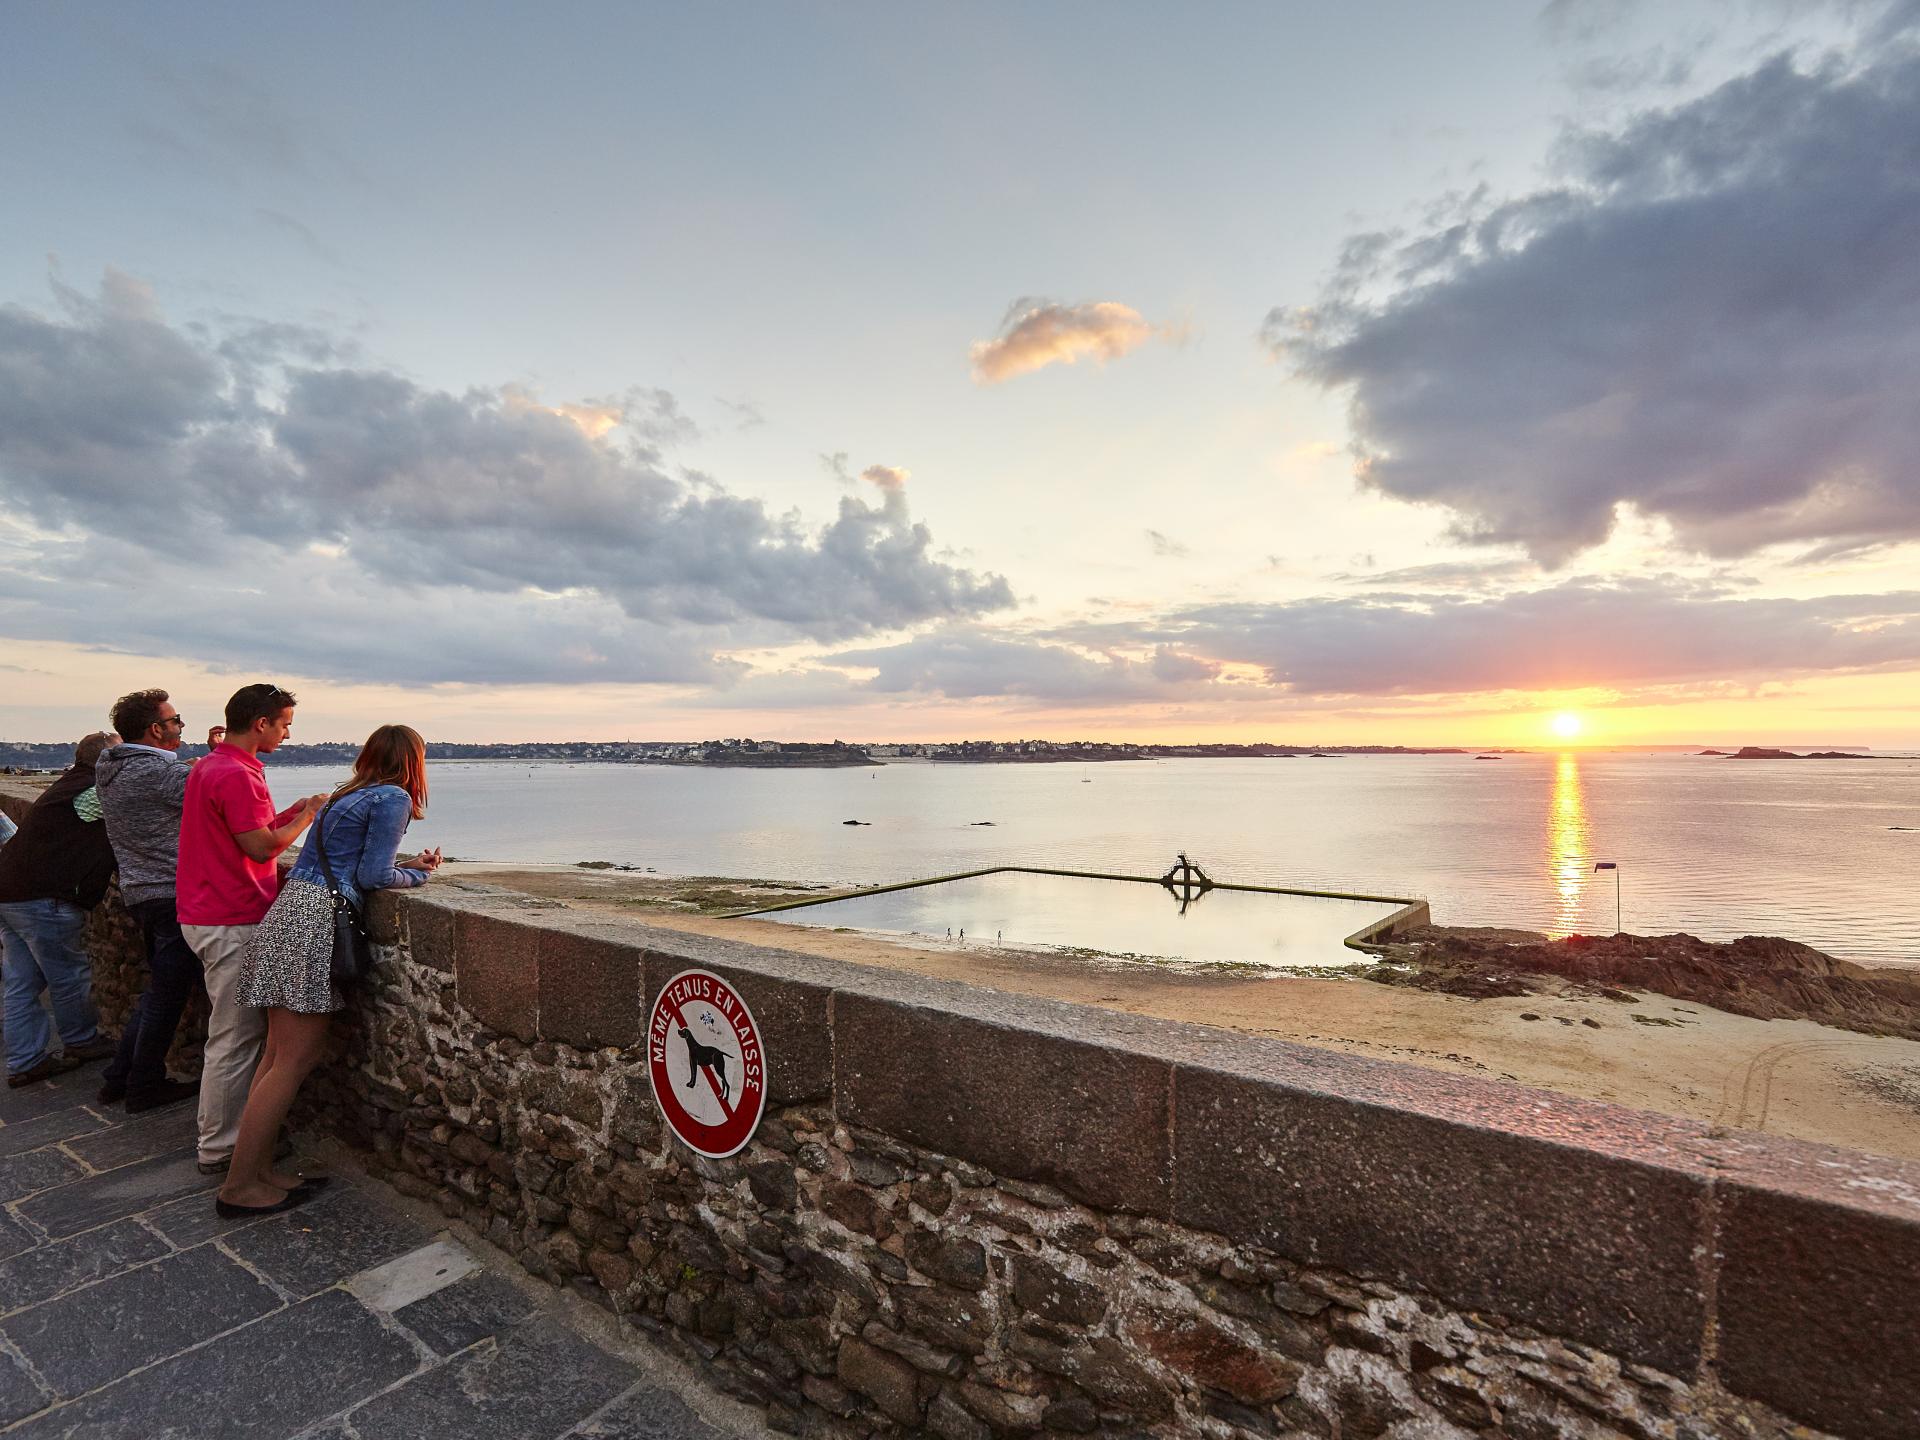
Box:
175;685;326;1175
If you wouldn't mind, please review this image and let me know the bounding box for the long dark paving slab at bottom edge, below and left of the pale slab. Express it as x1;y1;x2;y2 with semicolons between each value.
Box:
8;1290;424;1440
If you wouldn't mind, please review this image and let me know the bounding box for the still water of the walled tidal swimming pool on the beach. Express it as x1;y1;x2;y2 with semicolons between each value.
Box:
755;870;1405;970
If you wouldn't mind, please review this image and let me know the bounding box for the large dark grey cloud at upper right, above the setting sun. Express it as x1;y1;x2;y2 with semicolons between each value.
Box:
1267;24;1920;564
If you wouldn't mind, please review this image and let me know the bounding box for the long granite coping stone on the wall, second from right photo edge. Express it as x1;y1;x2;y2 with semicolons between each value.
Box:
1173;1069;1709;1375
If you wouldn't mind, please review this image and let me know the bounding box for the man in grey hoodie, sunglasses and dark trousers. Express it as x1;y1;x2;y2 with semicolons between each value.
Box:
94;689;223;1114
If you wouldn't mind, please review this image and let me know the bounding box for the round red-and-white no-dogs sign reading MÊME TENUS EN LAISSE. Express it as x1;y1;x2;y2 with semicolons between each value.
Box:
647;970;766;1160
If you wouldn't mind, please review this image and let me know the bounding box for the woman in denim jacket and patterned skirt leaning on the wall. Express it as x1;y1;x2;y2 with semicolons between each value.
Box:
217;726;440;1217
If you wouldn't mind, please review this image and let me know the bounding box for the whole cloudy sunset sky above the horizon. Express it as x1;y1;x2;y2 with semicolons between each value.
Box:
0;0;1920;745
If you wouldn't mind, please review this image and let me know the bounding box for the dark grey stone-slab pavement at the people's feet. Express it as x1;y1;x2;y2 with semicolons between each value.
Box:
0;1064;766;1440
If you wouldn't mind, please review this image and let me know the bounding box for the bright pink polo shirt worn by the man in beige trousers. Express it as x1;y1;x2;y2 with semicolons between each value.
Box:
175;745;292;925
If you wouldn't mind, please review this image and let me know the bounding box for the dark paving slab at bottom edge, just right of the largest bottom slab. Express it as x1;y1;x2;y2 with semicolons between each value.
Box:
348;1319;637;1440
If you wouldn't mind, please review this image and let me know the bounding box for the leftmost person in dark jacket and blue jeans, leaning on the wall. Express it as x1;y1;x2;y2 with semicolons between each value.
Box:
0;732;119;1089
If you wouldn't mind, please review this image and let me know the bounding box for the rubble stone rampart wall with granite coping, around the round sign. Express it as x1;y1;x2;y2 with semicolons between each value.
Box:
7;783;1920;1440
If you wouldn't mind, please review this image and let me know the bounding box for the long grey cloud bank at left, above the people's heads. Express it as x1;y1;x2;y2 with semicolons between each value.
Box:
0;275;1012;695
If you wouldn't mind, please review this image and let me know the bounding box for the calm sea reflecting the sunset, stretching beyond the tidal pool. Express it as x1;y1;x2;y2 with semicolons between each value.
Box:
269;753;1920;964
